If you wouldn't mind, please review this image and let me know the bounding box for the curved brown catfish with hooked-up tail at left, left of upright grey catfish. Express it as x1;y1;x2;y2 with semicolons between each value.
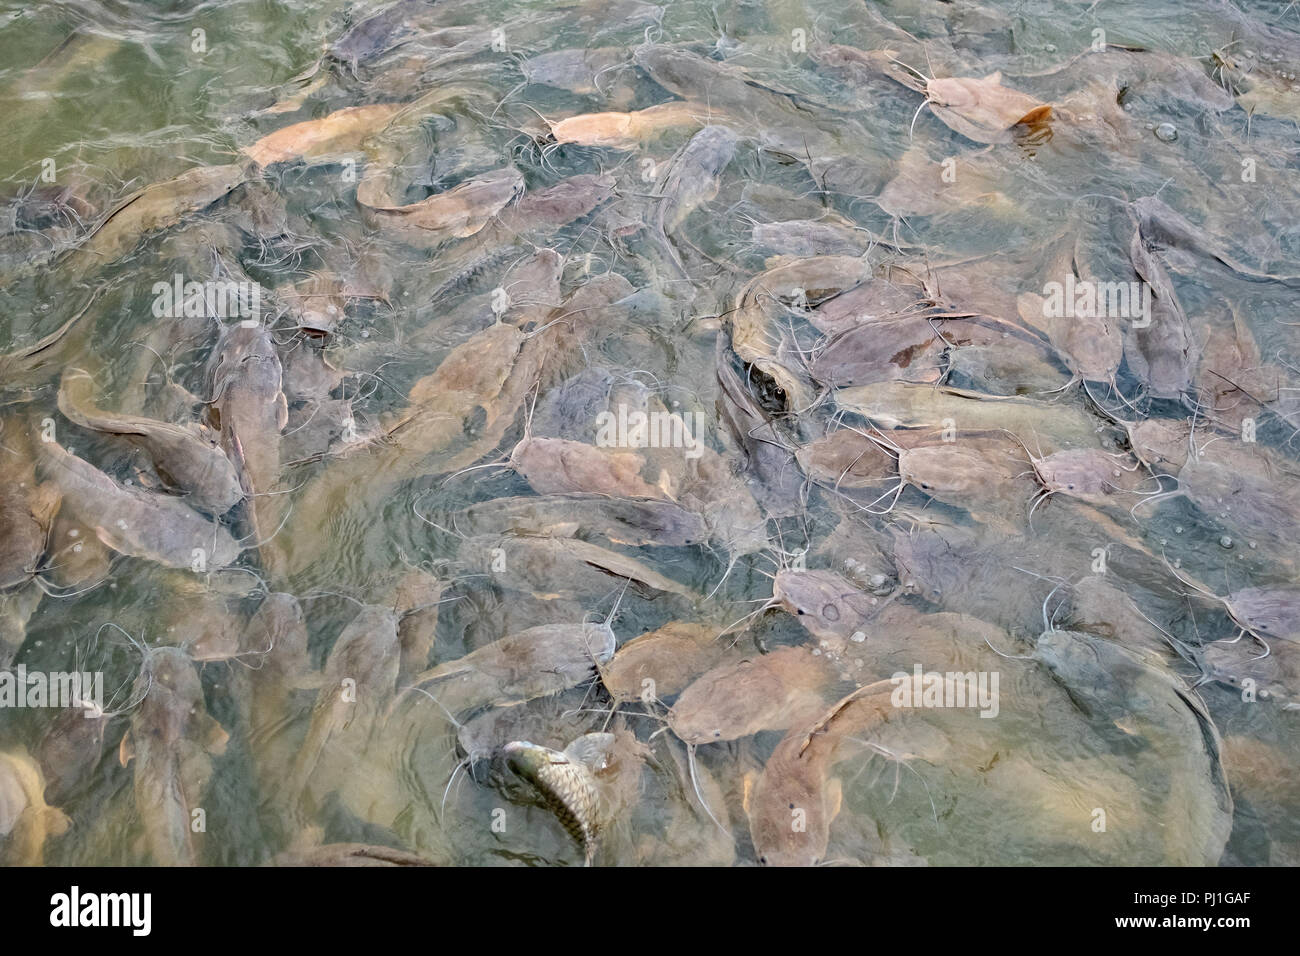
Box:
59;368;243;516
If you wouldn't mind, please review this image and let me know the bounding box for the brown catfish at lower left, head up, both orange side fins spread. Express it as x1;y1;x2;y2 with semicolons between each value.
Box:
120;648;229;866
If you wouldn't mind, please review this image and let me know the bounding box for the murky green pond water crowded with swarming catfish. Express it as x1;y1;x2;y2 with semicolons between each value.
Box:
0;0;1300;865
